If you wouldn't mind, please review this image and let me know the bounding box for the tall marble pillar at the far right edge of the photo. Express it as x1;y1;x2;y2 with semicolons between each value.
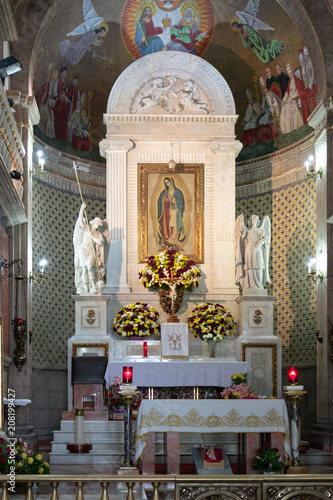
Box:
309;97;333;452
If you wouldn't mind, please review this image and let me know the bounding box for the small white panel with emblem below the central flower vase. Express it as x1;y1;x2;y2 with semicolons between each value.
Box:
161;323;188;359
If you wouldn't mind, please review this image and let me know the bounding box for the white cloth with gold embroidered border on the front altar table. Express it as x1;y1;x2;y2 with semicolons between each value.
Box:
135;399;290;463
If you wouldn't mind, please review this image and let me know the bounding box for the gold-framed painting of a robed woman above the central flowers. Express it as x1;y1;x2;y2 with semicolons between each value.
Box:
138;163;204;264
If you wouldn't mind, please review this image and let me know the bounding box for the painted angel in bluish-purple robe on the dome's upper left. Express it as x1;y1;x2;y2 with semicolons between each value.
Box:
58;0;109;66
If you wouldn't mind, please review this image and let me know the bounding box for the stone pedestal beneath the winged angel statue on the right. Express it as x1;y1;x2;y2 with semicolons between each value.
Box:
236;291;282;397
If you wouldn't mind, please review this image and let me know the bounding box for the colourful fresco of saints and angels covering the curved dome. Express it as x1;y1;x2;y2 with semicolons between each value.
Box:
34;0;316;161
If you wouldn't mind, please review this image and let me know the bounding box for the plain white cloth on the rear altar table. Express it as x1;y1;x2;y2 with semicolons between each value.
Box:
104;358;251;387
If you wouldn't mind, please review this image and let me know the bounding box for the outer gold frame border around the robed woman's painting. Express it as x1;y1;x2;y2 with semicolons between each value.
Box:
138;163;204;264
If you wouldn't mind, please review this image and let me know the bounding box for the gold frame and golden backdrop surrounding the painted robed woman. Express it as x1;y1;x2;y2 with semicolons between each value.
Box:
138;163;204;264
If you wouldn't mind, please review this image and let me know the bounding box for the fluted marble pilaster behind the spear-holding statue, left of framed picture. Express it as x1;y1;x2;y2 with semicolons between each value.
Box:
99;140;133;294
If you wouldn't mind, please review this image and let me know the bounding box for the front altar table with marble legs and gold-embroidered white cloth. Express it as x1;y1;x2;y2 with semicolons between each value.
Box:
135;399;290;474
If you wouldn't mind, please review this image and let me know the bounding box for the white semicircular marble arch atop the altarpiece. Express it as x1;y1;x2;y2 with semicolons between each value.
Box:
107;52;236;116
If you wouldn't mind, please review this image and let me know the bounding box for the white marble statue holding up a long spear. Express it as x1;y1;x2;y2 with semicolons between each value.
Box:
73;203;109;295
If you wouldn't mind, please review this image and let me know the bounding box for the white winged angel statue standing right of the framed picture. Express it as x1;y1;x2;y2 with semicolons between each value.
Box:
234;214;271;295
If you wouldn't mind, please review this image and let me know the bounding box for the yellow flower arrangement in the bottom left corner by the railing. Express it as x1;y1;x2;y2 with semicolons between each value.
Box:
0;438;50;474
